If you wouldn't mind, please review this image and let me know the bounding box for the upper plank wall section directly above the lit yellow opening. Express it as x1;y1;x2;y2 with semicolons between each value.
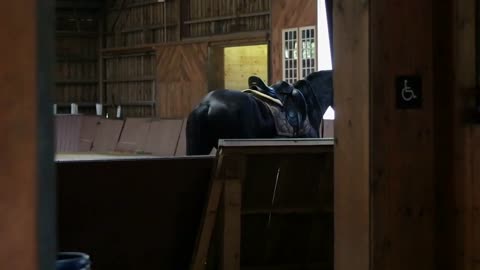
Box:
182;0;270;38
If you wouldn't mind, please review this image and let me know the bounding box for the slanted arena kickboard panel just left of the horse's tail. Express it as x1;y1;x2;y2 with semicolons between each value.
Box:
143;119;183;156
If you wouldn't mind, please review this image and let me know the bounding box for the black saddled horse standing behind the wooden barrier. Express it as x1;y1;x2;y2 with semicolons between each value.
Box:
186;71;333;155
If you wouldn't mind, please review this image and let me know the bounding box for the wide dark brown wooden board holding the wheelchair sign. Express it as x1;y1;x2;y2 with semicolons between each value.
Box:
370;0;435;270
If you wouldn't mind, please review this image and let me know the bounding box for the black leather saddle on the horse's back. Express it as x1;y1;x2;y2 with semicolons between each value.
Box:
248;76;307;137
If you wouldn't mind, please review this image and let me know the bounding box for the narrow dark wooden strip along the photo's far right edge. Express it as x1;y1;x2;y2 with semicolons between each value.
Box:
451;0;480;269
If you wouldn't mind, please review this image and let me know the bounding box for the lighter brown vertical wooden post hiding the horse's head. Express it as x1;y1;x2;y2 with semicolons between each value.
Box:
333;1;372;270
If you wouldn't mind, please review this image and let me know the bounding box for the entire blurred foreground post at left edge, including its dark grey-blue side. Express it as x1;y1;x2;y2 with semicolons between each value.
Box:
0;0;55;270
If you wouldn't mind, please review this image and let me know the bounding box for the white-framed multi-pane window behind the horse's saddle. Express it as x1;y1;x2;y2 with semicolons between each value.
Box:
282;25;318;83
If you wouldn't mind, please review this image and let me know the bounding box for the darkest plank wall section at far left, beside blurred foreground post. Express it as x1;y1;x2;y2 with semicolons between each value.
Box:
53;8;99;113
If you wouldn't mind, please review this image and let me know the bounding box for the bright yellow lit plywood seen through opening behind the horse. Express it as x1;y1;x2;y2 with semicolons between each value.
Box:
224;45;268;90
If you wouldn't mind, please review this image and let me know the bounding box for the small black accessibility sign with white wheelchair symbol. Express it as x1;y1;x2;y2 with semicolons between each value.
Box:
395;76;423;109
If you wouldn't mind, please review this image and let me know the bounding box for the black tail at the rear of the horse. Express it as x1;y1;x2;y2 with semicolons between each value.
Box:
186;104;214;156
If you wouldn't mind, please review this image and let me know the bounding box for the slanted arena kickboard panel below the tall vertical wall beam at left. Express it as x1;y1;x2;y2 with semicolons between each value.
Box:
92;119;123;152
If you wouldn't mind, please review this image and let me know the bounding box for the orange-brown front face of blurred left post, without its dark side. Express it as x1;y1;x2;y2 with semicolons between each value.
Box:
0;0;40;270
